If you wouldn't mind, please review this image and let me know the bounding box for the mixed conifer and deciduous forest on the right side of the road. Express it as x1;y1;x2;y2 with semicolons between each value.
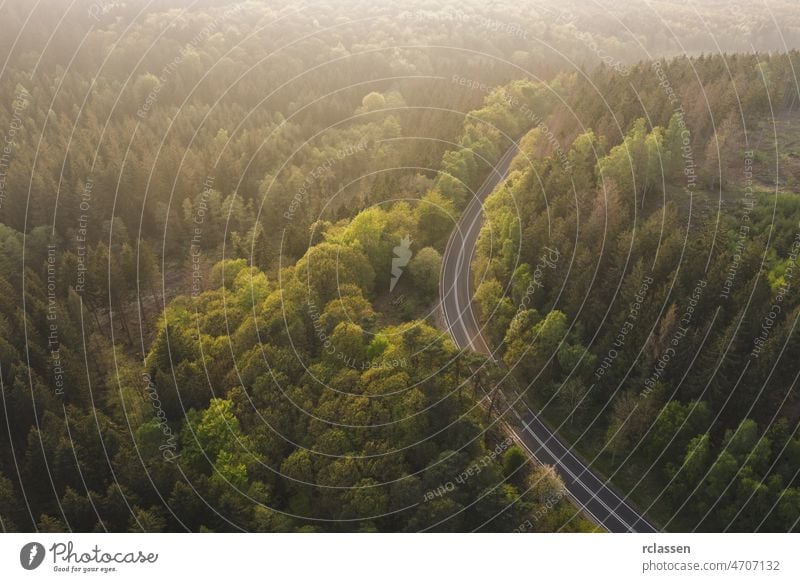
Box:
473;52;800;532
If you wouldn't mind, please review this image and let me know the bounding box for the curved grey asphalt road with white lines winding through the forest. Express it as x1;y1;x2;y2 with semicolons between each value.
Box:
439;146;658;533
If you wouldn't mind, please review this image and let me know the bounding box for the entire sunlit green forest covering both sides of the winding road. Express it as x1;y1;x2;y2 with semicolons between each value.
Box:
0;0;800;532
